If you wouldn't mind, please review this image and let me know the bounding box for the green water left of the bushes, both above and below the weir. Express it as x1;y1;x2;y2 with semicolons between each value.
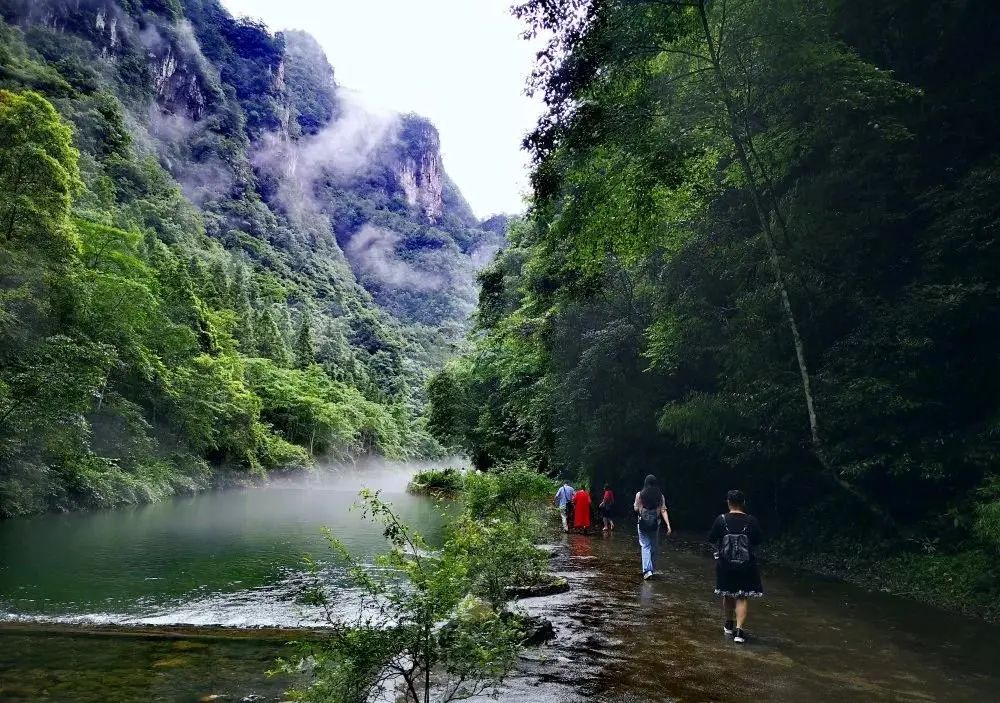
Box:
0;467;443;703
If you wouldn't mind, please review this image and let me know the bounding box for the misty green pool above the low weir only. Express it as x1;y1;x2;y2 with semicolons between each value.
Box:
0;460;458;627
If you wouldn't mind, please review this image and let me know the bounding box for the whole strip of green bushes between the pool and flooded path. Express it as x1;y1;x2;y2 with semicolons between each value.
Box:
278;467;568;703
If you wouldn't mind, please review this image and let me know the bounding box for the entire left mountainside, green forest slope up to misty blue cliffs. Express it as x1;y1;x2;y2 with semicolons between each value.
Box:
0;0;503;516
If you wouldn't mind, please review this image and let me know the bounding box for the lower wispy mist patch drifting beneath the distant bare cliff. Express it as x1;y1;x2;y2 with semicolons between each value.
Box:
345;224;448;291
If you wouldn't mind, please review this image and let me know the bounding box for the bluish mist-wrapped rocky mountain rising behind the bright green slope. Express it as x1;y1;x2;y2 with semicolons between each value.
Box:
0;0;496;324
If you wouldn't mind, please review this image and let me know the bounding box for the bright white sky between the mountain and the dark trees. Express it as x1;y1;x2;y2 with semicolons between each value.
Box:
223;0;541;217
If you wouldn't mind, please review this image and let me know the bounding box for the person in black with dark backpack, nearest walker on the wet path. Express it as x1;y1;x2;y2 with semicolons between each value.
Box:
708;490;764;644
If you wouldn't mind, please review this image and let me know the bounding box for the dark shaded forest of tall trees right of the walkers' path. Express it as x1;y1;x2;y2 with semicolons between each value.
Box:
431;0;1000;607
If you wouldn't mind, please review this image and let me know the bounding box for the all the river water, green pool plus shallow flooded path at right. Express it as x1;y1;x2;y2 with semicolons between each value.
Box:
0;468;1000;703
